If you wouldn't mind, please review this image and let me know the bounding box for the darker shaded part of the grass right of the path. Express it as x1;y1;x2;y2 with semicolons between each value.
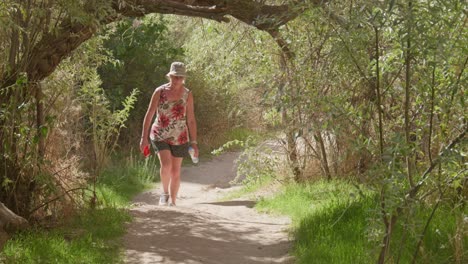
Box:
294;195;375;263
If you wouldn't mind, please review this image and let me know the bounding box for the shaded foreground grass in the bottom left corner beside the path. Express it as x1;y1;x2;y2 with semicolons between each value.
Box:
2;208;131;263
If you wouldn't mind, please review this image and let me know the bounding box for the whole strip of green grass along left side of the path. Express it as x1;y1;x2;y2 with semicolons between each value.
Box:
0;155;156;263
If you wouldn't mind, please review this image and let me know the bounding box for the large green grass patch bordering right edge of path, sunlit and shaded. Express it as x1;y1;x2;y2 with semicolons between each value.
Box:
257;181;376;263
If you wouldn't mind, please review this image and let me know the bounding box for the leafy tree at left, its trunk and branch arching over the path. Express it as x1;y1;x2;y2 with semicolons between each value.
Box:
0;0;310;219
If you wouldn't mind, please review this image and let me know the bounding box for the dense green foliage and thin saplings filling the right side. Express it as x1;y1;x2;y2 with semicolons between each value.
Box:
178;1;468;263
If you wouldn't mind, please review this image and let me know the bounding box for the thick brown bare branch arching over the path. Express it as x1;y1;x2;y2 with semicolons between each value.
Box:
1;0;303;87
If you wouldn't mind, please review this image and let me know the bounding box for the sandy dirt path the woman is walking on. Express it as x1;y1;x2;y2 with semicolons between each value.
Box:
124;153;292;264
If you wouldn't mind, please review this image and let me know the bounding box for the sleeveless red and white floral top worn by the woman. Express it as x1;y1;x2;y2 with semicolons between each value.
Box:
150;85;190;145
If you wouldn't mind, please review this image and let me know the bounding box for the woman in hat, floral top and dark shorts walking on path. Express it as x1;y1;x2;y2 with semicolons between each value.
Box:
140;62;198;206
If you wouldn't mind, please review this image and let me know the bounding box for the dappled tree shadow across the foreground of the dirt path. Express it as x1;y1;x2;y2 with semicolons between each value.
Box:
126;207;289;264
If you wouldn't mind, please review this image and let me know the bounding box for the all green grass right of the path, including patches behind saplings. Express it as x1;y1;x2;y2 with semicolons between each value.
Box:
256;181;468;264
